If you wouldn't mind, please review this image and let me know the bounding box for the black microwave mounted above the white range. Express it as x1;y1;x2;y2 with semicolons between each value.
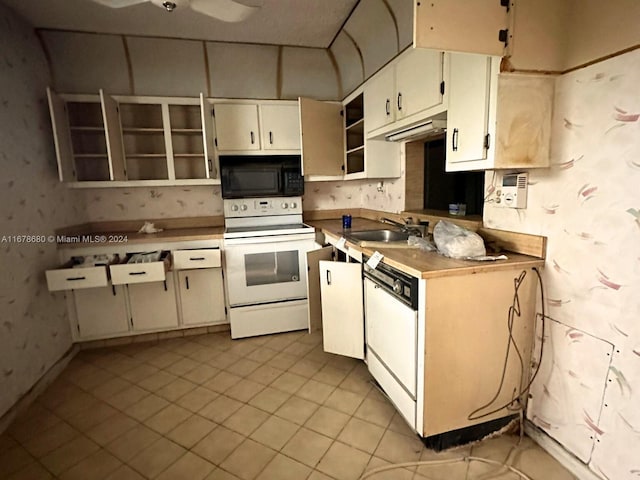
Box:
220;155;304;198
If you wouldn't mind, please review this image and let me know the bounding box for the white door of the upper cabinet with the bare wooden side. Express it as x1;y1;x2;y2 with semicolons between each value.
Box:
447;53;491;171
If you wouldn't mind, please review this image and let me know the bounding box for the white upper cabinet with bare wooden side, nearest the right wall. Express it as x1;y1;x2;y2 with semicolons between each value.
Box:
446;53;555;172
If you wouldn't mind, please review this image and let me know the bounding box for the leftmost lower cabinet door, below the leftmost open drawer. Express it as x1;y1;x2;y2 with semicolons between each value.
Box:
73;285;129;339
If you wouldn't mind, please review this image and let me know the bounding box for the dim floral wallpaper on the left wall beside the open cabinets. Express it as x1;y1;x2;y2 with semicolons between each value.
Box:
0;3;86;417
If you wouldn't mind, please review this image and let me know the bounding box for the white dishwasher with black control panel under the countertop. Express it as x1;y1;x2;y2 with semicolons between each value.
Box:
363;259;418;429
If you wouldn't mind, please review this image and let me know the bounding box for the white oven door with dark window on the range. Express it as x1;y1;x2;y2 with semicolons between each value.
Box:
224;234;315;307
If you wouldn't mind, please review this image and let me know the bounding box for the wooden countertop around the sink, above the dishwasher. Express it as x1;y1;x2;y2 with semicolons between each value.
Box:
309;218;544;279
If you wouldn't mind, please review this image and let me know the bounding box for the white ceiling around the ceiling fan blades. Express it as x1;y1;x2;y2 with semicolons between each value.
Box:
0;0;358;48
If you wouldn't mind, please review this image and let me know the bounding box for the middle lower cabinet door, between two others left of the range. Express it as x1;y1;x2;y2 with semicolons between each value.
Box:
127;275;178;331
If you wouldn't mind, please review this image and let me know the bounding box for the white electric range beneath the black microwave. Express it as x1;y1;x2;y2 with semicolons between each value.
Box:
223;197;316;338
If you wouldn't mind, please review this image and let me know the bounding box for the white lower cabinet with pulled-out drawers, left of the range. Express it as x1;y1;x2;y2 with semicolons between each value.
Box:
45;240;227;341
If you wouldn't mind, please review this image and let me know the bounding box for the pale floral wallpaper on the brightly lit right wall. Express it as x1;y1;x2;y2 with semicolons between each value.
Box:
484;50;640;480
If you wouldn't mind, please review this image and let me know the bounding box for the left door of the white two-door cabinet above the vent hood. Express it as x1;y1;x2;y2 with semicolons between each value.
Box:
364;66;396;132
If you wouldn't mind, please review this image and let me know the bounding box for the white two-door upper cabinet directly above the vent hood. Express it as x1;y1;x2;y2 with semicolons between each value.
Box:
364;49;446;138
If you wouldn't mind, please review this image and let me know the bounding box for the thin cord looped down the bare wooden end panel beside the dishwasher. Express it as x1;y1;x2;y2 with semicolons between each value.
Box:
467;267;547;423
